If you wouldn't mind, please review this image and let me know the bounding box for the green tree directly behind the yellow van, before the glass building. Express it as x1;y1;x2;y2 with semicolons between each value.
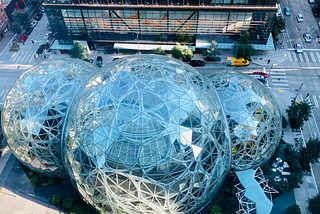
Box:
235;32;256;60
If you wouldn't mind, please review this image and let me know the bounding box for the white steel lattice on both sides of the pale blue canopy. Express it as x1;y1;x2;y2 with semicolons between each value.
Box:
235;167;279;214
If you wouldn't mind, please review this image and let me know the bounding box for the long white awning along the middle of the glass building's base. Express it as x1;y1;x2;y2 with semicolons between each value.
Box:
113;43;195;51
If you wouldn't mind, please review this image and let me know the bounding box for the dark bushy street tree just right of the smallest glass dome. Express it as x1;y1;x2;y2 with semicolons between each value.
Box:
286;101;312;128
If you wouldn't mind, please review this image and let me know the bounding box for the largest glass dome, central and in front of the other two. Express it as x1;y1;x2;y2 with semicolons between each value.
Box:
63;55;231;214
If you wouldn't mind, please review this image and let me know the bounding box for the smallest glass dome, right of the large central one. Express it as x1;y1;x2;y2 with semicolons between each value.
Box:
209;71;282;170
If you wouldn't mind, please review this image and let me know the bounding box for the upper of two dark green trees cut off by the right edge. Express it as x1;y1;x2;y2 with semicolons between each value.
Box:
299;138;320;171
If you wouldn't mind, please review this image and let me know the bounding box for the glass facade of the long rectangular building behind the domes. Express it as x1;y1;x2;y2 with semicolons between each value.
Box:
45;0;277;45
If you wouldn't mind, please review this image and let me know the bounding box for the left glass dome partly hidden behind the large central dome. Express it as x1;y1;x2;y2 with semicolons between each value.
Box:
2;58;96;176
